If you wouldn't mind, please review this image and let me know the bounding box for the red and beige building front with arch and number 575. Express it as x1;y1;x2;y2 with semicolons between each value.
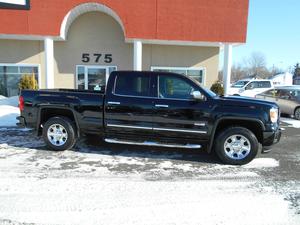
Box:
0;0;249;96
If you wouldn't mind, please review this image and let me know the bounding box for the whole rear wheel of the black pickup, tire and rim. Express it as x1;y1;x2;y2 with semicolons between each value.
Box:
43;117;77;151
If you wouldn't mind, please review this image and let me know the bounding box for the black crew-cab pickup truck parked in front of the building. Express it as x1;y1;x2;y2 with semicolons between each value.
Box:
18;71;281;165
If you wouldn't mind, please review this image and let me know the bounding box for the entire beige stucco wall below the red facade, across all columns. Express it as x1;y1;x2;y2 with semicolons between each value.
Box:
0;12;219;88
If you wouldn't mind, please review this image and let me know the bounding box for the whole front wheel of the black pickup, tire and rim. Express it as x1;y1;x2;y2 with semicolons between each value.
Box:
214;127;259;165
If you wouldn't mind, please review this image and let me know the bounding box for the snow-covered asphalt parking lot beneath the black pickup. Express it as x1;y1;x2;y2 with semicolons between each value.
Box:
0;118;300;224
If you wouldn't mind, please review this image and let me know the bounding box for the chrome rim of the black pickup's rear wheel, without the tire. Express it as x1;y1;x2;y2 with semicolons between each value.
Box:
47;124;68;146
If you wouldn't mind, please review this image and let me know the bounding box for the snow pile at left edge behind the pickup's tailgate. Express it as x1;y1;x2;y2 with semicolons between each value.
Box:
0;95;20;127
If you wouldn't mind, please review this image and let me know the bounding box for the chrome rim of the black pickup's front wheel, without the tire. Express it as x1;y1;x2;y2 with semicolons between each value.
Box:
224;135;251;160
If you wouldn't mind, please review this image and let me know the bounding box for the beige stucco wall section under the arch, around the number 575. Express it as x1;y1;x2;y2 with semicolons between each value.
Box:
54;12;133;88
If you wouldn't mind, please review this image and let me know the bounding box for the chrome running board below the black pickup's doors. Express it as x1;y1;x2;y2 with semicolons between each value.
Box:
104;138;201;149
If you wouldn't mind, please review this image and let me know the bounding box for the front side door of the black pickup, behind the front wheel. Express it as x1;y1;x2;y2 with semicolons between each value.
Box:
153;74;211;143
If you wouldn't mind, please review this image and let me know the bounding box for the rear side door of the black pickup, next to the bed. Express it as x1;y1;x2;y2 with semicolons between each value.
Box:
105;72;153;139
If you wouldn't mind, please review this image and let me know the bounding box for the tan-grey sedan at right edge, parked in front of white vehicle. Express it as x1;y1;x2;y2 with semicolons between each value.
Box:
256;85;300;120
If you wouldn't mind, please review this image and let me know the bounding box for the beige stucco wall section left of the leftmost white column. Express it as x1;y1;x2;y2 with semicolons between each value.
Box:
0;40;45;88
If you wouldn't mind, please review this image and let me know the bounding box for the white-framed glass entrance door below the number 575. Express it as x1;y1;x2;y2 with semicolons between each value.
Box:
76;66;117;91
